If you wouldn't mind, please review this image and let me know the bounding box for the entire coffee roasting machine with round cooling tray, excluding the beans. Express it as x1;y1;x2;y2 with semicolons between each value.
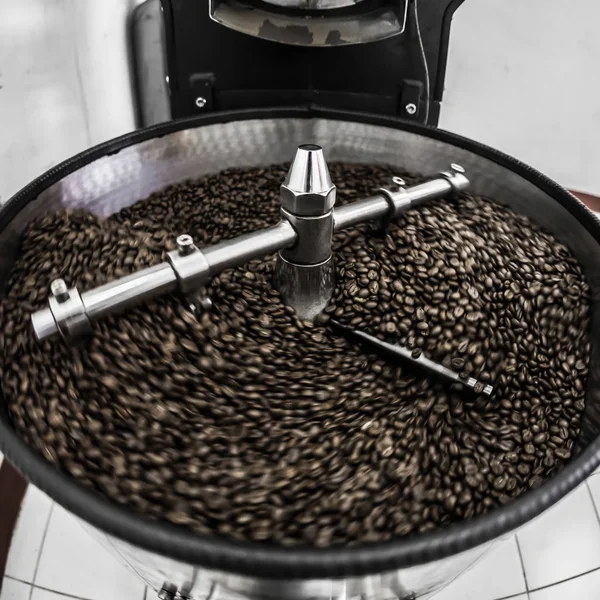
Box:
0;0;600;600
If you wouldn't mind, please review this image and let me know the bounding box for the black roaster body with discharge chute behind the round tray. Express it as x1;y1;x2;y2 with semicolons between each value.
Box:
132;0;463;126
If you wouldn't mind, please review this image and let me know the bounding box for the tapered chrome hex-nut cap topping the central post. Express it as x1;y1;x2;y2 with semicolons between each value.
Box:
280;144;335;217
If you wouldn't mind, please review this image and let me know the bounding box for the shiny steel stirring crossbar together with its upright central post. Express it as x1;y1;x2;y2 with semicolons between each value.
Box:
31;145;469;341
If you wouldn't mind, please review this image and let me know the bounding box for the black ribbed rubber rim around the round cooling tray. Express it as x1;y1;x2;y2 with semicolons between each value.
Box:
0;107;600;580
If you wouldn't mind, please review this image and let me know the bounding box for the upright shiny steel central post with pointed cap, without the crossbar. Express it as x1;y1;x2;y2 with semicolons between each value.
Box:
273;144;336;319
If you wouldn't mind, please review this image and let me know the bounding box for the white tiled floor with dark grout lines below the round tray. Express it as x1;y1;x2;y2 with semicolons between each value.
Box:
0;456;600;600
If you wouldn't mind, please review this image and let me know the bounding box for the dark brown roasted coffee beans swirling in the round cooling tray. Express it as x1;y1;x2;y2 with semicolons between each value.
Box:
0;164;590;546
